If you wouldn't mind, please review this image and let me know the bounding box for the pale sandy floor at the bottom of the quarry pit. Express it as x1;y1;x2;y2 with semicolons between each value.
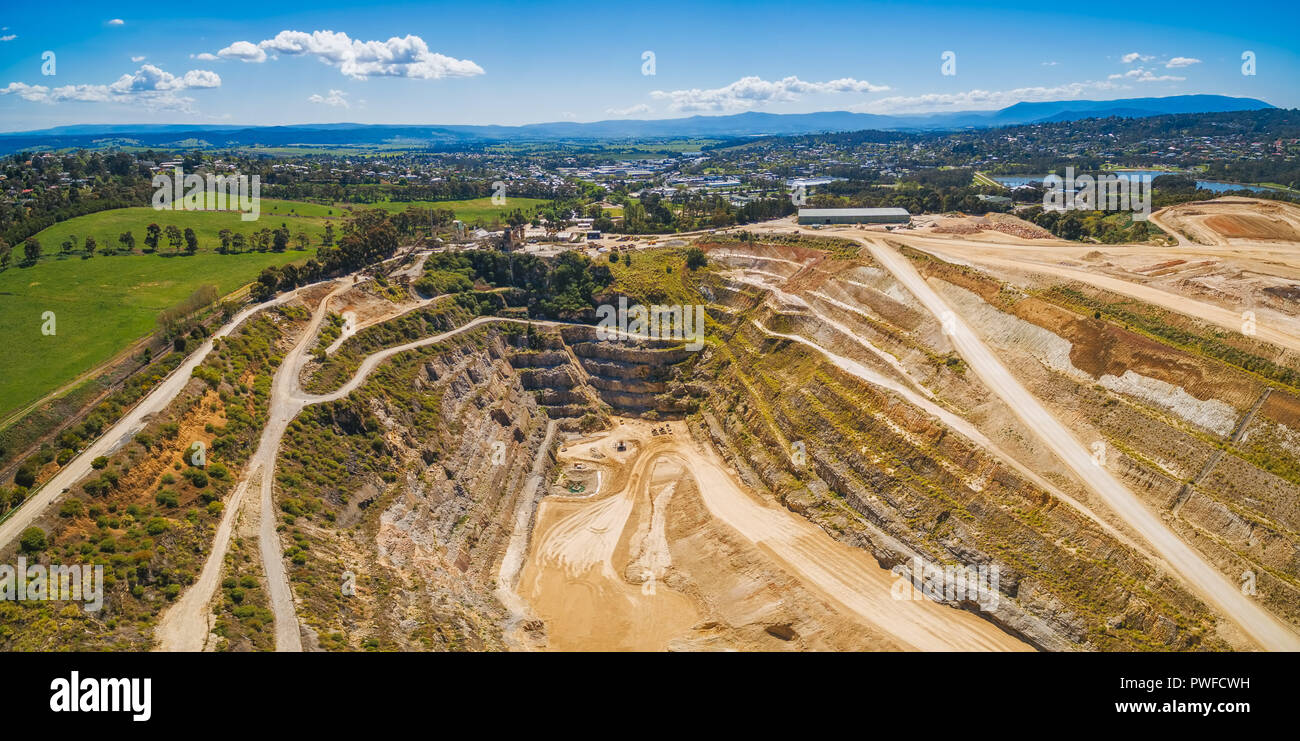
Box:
519;419;1030;650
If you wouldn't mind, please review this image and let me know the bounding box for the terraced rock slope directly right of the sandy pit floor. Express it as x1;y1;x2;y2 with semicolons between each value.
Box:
697;262;1223;650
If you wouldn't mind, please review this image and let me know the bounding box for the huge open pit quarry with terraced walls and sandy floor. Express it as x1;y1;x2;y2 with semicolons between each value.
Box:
5;202;1300;651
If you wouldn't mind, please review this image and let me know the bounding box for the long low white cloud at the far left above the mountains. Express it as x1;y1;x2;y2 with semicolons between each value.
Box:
0;64;221;111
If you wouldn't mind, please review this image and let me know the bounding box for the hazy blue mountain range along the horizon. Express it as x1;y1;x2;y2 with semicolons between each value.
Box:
0;95;1274;152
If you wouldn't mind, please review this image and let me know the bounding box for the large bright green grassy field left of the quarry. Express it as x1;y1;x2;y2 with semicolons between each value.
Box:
0;199;346;419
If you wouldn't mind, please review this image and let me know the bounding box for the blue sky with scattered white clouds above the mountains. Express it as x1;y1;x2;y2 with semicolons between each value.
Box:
0;0;1300;131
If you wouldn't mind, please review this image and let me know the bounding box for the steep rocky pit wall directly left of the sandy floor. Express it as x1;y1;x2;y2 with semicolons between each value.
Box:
280;325;613;650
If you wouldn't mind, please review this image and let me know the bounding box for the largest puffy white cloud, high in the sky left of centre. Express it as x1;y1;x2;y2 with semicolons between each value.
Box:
217;31;484;79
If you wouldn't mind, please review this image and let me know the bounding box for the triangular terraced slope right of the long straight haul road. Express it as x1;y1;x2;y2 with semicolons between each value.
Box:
911;252;1300;631
